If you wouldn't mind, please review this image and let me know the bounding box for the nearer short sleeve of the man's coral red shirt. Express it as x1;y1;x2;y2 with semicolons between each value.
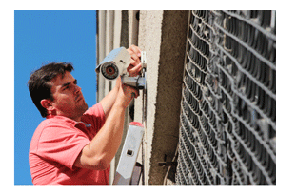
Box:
37;125;90;170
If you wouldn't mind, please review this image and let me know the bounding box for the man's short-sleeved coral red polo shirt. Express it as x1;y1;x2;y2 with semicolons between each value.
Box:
29;103;109;185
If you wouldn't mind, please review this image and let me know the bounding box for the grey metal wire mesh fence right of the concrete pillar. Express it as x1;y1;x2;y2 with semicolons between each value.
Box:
175;10;276;185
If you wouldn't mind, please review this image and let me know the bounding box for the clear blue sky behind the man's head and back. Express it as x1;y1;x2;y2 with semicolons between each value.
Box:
14;10;96;185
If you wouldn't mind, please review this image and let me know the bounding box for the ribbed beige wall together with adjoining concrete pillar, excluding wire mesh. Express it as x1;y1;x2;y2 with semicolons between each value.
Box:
97;10;188;185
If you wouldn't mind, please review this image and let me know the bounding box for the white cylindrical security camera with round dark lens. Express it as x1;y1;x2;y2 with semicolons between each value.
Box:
95;47;130;80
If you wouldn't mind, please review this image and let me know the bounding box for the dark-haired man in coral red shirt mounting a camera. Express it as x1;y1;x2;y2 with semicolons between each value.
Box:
29;45;141;185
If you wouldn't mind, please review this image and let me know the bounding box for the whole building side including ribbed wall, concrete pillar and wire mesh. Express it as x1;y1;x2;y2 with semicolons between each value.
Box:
97;10;276;185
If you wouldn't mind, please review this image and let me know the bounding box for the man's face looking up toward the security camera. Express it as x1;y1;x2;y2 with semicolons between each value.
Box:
50;71;88;122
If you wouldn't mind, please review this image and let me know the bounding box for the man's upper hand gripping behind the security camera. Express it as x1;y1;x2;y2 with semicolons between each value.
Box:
127;45;142;77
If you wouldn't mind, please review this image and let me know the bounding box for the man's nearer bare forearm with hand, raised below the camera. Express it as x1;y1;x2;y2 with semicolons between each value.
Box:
74;82;138;170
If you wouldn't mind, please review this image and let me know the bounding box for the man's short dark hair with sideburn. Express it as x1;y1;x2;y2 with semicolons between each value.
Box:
28;62;73;118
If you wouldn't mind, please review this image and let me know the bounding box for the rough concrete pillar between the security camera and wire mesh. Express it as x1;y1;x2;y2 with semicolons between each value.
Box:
135;10;188;185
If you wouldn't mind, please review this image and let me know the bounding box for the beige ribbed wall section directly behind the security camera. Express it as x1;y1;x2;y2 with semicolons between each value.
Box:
97;10;130;183
